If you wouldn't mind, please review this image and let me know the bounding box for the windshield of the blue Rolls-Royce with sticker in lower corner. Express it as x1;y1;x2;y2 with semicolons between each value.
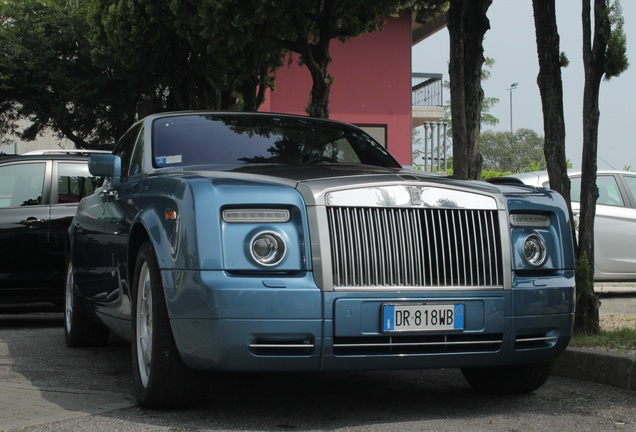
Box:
152;114;400;168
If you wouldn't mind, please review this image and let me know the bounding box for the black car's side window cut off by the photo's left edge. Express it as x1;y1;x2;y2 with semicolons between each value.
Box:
0;162;46;207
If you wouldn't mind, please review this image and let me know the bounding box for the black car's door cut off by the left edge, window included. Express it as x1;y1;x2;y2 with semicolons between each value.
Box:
0;161;54;298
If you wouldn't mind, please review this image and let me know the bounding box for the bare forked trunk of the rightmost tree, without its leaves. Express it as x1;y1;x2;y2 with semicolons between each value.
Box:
574;0;610;334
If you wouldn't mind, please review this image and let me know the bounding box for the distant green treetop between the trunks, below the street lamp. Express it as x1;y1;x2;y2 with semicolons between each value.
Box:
480;129;546;173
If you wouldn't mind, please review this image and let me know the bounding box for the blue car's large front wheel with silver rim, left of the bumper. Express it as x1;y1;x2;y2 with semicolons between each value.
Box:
132;242;206;409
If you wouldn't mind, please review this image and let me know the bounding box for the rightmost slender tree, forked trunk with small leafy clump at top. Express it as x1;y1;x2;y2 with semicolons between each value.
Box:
574;0;629;333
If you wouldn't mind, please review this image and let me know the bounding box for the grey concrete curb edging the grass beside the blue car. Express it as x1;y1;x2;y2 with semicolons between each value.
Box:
552;348;636;391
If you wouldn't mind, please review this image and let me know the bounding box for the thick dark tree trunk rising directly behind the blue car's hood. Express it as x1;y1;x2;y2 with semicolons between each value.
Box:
448;0;492;179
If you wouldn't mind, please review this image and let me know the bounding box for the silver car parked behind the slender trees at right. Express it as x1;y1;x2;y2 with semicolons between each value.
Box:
497;170;636;281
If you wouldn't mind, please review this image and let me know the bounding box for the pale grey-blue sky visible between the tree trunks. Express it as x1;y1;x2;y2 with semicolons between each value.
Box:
412;0;636;170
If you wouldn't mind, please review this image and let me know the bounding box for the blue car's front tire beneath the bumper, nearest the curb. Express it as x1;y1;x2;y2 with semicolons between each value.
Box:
462;362;553;395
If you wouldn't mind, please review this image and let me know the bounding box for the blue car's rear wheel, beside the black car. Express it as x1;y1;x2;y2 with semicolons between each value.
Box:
64;260;110;347
